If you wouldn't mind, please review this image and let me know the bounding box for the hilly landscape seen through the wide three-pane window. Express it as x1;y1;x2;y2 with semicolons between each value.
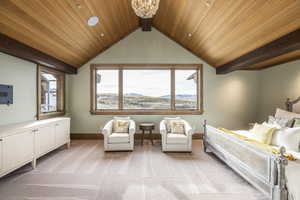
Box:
97;93;197;109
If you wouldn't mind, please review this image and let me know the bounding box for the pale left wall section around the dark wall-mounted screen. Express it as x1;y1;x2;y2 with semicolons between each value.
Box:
0;52;36;125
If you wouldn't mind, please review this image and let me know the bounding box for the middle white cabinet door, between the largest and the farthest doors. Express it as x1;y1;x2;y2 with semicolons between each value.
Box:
36;124;55;156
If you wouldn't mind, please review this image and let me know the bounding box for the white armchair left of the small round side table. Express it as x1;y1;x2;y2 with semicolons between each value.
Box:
102;120;136;151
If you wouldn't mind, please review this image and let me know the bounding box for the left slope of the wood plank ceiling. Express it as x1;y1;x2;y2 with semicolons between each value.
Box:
0;0;138;67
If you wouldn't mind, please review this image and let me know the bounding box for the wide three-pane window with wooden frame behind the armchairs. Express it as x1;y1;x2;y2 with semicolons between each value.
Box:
91;64;202;114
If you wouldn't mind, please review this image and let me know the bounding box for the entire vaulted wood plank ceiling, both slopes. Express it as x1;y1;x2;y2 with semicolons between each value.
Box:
0;0;300;73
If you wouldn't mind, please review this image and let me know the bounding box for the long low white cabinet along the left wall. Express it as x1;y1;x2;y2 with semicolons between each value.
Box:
0;117;70;177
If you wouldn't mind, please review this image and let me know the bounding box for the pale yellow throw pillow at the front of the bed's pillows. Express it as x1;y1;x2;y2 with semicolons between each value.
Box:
251;124;277;144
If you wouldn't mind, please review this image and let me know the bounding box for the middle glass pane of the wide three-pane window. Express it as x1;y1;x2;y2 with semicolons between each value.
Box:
123;70;171;110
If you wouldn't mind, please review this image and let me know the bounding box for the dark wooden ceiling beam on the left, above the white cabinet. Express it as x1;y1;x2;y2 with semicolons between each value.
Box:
0;33;77;74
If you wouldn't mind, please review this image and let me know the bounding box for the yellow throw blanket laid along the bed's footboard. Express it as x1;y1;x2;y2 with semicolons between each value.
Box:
219;128;297;160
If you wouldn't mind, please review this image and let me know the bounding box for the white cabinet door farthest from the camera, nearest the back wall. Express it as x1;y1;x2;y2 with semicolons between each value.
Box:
55;120;70;146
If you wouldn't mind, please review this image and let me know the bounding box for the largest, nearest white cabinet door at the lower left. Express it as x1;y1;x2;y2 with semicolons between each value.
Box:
2;131;34;171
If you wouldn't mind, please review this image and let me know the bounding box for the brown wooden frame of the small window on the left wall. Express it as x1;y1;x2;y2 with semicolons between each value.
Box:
37;65;66;120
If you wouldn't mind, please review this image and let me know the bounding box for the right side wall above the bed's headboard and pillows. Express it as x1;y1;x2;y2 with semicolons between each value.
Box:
258;60;300;121
